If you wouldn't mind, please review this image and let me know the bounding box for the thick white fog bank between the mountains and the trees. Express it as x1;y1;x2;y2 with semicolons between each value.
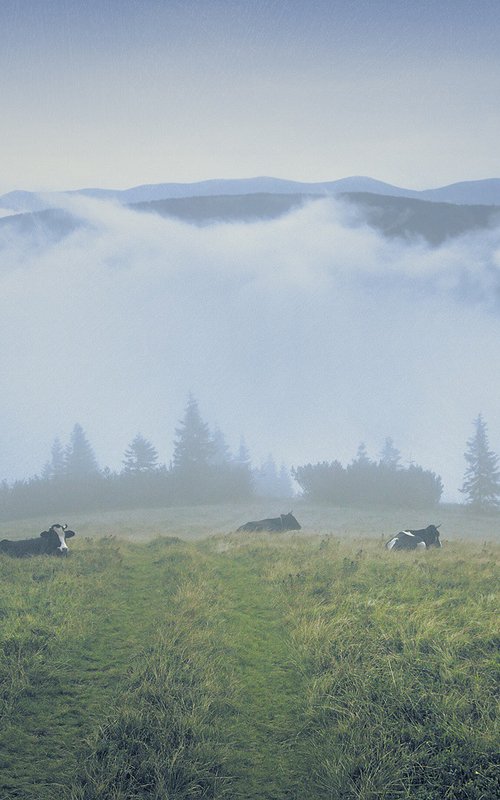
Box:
0;197;500;498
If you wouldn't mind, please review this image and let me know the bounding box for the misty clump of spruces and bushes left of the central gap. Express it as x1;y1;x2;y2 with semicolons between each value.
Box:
0;396;294;519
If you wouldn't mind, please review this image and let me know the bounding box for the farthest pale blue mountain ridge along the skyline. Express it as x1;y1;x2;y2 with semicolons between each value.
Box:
0;176;500;212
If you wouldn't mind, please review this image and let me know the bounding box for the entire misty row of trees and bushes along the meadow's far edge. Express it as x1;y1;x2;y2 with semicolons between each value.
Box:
0;395;500;519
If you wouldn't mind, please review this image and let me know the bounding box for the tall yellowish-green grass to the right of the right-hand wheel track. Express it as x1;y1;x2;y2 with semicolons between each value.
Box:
264;540;499;800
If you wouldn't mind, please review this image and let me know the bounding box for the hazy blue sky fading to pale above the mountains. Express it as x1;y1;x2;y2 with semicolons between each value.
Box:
0;0;500;193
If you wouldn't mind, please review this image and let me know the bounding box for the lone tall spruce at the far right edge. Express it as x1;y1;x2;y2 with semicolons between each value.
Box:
460;414;500;511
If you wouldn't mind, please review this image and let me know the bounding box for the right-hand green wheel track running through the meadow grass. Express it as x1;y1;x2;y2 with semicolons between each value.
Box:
217;558;304;800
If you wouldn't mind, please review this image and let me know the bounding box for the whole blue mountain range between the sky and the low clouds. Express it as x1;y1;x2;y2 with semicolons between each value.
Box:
0;178;500;246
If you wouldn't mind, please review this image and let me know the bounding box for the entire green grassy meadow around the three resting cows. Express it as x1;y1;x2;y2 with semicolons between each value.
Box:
0;504;500;800
